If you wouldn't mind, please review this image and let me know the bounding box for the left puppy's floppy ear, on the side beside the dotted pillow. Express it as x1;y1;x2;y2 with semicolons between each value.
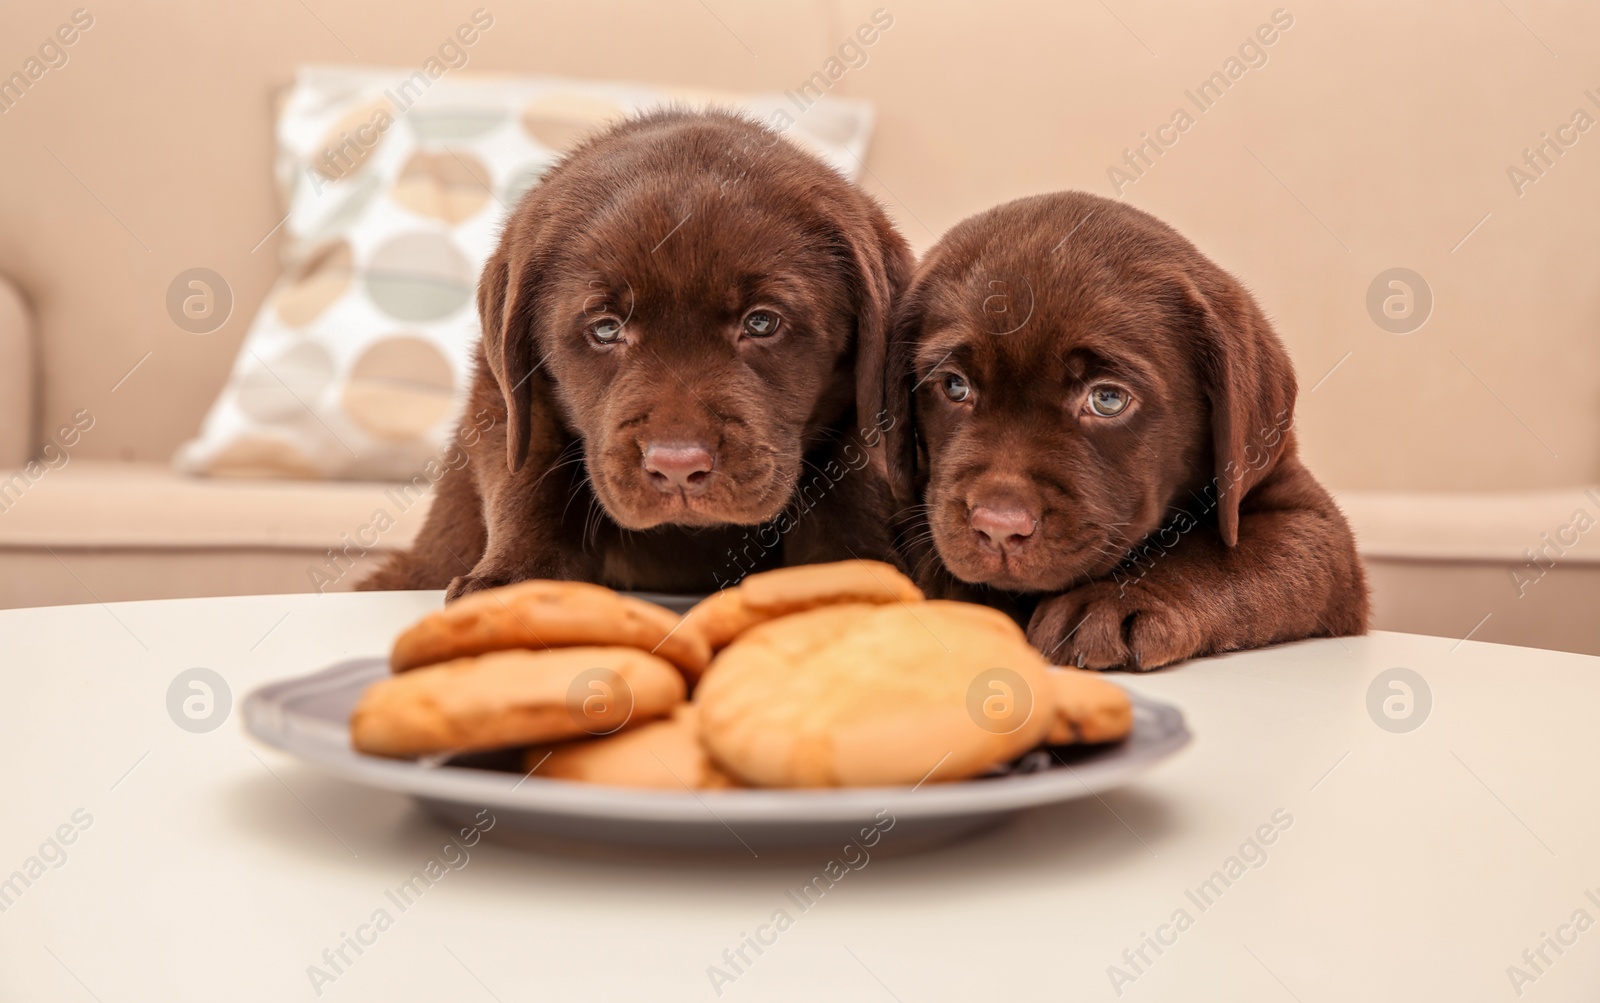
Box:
478;236;542;474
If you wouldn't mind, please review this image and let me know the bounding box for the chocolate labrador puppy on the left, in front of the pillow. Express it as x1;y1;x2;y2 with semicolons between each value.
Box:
360;110;912;598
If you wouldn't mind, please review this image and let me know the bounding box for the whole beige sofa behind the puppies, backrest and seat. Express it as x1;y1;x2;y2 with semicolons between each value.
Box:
0;0;1600;653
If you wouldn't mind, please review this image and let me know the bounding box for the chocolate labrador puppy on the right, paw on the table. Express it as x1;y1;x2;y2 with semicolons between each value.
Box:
886;192;1368;669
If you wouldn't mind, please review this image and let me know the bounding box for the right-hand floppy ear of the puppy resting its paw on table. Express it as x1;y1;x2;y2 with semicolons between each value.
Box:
1179;267;1296;547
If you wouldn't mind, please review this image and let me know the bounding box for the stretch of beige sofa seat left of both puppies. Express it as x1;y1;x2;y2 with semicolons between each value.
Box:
0;458;432;607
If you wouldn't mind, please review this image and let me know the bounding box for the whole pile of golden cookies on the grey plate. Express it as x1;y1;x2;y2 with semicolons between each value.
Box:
350;561;1133;790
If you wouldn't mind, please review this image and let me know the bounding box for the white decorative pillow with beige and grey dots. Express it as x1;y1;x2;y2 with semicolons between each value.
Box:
174;61;872;480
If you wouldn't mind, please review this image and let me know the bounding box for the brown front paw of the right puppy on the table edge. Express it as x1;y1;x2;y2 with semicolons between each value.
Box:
1027;582;1205;672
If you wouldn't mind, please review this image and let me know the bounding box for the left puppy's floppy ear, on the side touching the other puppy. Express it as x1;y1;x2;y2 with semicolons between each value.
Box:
843;206;912;447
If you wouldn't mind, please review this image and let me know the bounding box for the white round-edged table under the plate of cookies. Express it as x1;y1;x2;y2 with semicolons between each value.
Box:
0;593;1600;1003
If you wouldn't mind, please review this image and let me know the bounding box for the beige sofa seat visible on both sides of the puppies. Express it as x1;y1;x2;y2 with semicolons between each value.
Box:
0;456;1600;654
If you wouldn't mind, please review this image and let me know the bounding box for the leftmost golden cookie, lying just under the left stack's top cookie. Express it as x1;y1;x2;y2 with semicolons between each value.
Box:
350;646;685;757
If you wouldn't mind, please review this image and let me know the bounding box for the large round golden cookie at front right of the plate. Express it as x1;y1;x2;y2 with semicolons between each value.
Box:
694;601;1056;787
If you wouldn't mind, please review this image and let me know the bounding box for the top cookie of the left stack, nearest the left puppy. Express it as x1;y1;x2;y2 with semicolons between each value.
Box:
389;581;710;678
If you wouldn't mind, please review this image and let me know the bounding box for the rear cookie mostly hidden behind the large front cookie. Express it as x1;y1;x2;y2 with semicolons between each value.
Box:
683;560;923;651
